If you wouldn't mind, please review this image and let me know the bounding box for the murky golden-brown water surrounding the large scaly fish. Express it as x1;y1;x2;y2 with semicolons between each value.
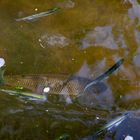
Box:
0;0;140;140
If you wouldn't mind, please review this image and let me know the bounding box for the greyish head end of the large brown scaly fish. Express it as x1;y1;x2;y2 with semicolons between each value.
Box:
60;77;108;104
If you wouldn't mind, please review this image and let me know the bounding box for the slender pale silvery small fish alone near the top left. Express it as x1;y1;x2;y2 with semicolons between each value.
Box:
15;7;60;22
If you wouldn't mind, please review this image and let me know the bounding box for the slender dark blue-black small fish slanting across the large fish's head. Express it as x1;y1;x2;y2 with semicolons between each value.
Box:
84;59;124;92
